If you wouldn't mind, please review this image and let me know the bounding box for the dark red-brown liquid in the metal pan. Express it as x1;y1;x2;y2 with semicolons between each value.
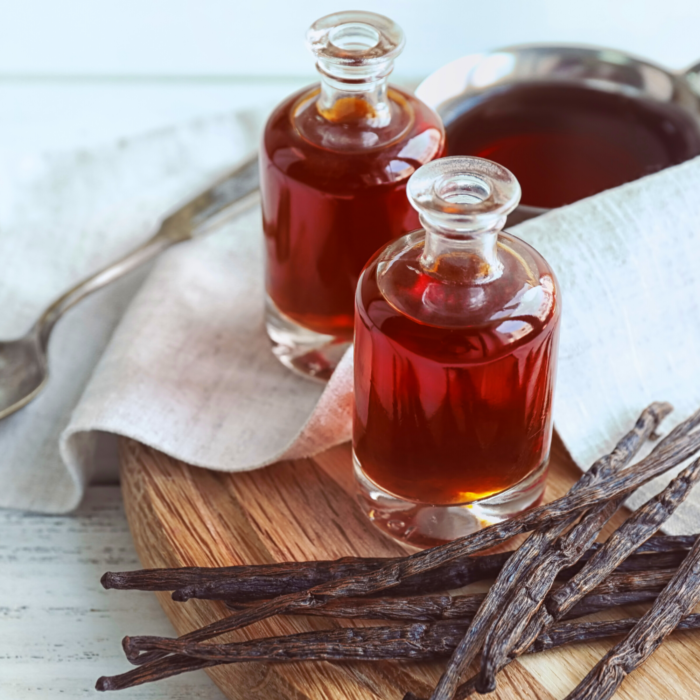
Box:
447;83;700;208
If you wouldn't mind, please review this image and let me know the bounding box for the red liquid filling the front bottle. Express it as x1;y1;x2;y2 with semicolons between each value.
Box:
353;238;559;505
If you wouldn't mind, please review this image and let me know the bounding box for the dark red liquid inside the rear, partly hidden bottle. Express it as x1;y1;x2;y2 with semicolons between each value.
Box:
260;89;445;340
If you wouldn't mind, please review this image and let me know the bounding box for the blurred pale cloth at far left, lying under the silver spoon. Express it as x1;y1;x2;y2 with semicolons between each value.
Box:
0;110;268;512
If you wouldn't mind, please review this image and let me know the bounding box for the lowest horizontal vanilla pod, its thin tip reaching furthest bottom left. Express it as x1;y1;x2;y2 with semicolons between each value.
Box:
96;615;700;700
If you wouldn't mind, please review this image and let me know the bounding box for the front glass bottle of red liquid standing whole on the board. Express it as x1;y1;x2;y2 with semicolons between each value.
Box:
353;156;560;546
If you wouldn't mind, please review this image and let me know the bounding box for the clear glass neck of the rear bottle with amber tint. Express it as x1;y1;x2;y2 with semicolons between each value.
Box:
316;66;391;129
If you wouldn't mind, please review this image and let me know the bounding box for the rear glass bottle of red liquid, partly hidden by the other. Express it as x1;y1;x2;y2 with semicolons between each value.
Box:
260;12;445;379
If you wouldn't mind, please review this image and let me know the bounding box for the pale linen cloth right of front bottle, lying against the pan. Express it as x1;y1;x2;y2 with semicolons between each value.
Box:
513;158;700;534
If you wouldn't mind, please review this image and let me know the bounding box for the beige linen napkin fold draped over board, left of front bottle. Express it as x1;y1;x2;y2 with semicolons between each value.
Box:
61;208;352;482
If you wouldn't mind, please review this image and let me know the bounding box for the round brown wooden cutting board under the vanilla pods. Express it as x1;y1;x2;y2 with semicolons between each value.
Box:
121;439;700;700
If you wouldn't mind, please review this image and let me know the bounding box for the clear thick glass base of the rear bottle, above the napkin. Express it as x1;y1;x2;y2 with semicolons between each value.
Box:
265;296;351;382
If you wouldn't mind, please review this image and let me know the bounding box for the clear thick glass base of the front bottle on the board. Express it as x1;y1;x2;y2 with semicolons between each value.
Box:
353;452;549;549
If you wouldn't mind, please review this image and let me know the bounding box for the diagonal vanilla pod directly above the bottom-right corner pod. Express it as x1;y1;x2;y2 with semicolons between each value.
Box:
477;460;700;693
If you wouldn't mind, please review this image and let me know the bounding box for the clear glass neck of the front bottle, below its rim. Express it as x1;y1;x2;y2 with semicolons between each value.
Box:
420;214;504;284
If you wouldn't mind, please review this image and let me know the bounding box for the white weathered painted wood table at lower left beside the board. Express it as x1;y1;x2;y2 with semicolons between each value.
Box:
0;486;224;700
